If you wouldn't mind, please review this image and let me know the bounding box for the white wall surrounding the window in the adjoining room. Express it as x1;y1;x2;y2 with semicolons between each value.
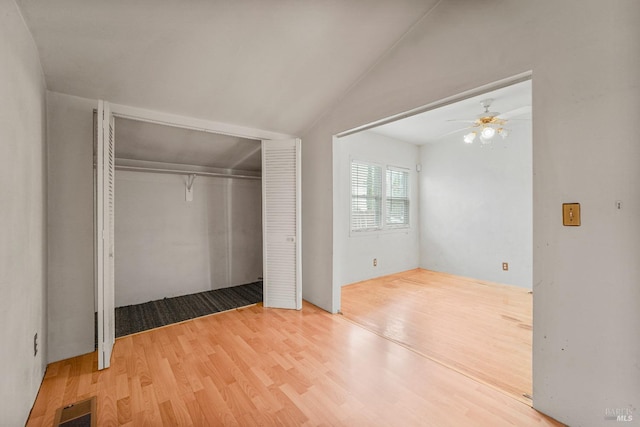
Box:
334;131;420;285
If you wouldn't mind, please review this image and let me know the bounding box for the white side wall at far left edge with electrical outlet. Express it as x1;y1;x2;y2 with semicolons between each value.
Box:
0;0;47;426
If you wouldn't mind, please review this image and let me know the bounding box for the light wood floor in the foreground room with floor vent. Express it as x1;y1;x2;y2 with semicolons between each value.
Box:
28;303;558;427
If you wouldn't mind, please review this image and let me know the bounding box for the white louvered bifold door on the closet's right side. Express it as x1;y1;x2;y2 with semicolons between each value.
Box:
262;139;302;310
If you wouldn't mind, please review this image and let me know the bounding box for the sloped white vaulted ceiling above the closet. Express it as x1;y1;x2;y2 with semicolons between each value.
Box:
18;0;437;135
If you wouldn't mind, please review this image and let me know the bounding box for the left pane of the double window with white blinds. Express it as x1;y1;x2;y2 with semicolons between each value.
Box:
351;161;382;230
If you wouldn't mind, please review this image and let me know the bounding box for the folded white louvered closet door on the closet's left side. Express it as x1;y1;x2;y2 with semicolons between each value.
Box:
95;101;115;369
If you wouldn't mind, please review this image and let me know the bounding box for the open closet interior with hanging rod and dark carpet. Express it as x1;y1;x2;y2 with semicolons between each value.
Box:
95;116;263;344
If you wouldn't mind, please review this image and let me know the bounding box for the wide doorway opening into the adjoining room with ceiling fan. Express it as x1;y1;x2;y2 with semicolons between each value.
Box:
334;75;533;404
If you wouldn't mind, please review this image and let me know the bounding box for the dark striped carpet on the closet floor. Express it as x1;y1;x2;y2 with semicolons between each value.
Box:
116;281;262;338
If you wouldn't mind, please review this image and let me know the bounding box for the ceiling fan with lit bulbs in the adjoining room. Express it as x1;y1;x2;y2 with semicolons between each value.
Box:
449;98;531;144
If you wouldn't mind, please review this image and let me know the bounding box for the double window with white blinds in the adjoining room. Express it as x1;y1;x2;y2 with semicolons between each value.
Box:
351;160;409;231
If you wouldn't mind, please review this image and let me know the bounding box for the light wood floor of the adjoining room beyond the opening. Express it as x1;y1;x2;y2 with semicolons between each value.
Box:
342;269;533;404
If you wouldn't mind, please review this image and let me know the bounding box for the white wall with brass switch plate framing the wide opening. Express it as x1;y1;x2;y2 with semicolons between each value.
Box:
302;0;640;426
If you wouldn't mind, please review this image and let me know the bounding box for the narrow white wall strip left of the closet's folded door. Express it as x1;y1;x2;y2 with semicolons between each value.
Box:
47;92;98;362
